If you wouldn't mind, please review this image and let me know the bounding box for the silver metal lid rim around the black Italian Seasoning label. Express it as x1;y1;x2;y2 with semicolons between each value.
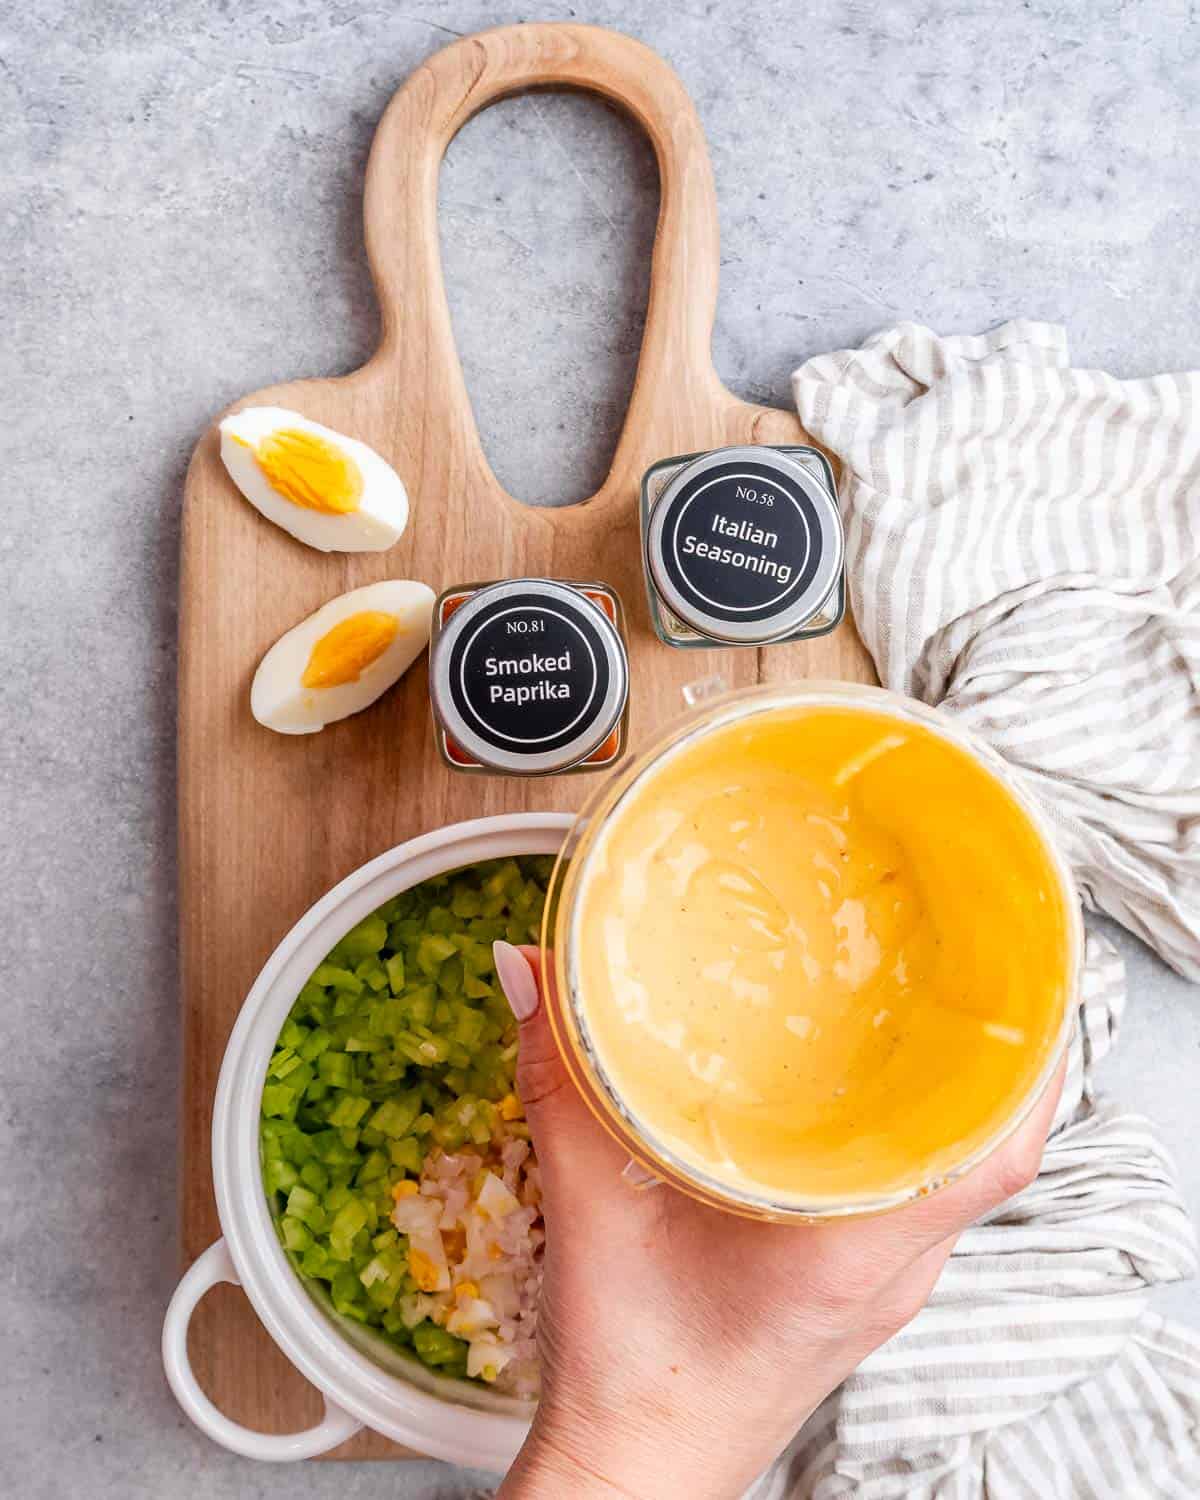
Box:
645;444;845;645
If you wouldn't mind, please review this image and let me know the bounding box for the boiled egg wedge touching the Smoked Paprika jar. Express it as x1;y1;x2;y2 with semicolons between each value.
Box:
251;579;434;735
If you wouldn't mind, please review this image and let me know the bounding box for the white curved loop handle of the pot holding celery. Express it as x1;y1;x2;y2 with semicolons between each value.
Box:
162;1239;363;1463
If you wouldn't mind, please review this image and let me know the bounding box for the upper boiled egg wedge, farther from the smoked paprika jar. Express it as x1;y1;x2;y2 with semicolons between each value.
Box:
221;407;408;552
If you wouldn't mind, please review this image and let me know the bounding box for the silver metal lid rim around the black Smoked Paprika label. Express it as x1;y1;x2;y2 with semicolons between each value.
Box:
429;578;629;776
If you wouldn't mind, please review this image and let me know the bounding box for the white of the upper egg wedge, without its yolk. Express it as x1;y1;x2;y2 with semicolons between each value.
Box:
221;407;408;552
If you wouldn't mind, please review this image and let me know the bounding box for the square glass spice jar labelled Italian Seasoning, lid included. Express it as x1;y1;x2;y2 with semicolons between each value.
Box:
641;446;846;650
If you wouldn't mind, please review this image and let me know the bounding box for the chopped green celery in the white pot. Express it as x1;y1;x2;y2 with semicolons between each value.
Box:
261;857;554;1379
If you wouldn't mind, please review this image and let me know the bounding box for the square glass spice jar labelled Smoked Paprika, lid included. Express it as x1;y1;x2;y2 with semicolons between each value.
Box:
429;578;629;776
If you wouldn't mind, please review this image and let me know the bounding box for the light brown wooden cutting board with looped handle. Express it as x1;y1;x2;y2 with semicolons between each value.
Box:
179;24;873;1458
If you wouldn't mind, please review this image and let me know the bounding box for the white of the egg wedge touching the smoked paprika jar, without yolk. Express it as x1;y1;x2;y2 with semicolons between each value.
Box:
251;579;434;735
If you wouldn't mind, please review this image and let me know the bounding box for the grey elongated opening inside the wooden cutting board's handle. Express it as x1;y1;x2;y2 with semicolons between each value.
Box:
438;90;659;506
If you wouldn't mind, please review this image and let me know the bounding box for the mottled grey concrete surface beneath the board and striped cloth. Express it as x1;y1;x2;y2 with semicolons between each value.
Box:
0;0;1200;1500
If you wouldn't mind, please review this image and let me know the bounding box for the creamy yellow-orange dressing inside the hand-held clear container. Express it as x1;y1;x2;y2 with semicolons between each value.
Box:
572;707;1073;1203
